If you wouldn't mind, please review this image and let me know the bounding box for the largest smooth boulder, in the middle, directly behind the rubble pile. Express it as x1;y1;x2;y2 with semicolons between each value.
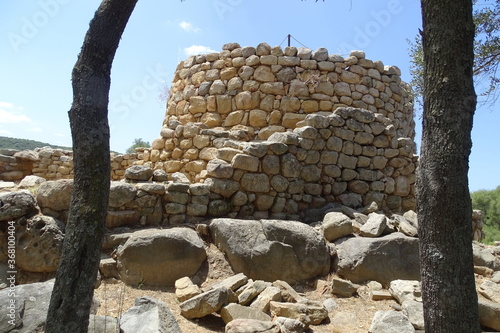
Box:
209;218;330;282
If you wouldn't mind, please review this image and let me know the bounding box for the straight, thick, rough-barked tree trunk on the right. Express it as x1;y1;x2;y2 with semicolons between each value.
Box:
417;0;481;333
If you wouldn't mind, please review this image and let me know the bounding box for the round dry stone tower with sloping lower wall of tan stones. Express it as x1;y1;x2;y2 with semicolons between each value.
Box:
139;43;417;213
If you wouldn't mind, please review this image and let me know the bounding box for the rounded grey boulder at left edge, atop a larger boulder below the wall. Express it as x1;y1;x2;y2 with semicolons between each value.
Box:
0;191;38;221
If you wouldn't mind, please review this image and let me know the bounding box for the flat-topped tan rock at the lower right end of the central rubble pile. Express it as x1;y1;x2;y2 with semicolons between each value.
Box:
269;301;328;326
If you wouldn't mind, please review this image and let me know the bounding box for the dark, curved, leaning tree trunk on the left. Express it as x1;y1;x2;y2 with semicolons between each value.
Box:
45;0;137;333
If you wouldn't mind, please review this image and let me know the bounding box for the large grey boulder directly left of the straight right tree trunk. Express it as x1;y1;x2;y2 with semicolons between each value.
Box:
335;232;420;286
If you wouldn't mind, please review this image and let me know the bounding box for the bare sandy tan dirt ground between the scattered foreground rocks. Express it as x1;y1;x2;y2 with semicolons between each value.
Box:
95;244;397;333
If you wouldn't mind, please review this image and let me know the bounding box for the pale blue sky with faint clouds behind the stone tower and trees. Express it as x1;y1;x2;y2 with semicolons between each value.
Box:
0;0;500;191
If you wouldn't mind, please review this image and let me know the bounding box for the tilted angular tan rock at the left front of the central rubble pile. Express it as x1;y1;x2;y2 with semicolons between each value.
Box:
179;287;229;319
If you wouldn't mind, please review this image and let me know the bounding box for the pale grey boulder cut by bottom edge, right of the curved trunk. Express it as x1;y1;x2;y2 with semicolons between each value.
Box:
120;296;182;333
